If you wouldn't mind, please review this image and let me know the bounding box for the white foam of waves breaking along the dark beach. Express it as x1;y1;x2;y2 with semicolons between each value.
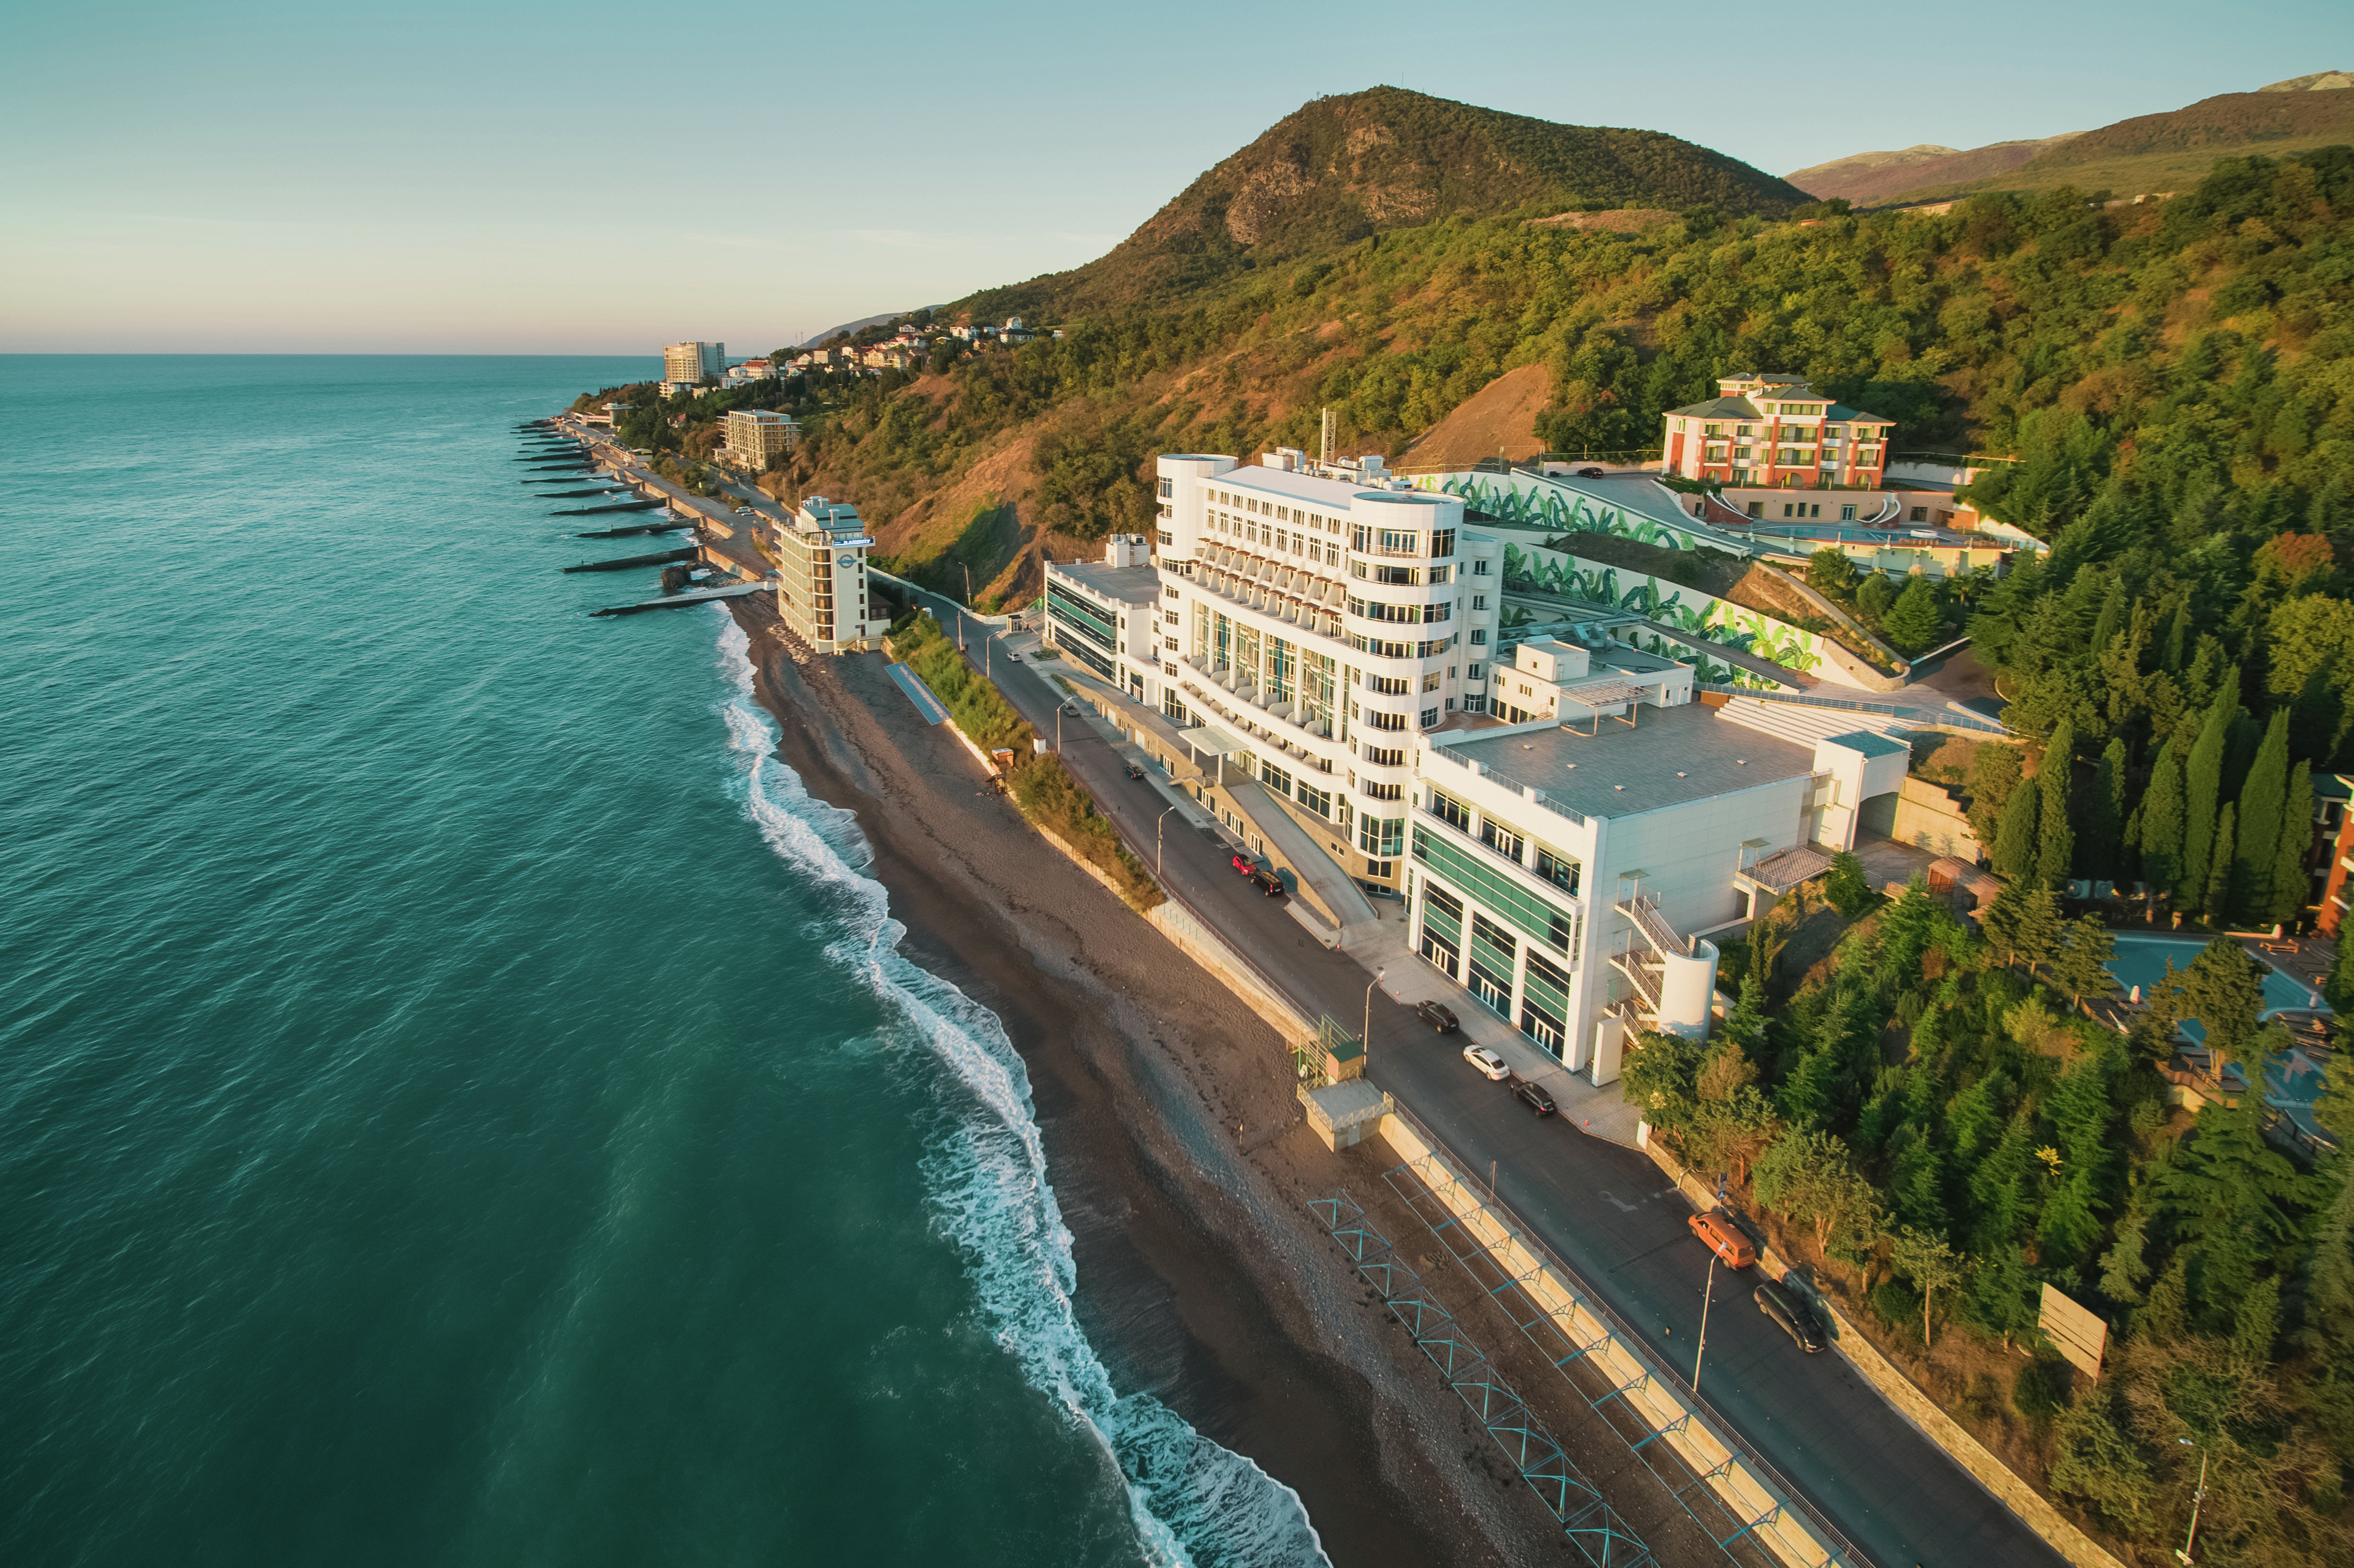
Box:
718;617;1330;1568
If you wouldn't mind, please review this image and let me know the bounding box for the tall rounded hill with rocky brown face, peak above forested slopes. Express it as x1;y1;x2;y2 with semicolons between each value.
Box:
951;87;1808;320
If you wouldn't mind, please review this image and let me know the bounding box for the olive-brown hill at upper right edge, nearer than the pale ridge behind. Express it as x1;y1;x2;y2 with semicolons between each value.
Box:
1883;87;2354;205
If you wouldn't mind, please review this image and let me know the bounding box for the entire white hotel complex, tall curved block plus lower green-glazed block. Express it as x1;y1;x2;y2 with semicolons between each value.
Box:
1048;452;1909;1083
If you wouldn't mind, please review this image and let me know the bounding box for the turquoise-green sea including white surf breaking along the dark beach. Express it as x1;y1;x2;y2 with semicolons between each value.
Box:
0;356;1323;1568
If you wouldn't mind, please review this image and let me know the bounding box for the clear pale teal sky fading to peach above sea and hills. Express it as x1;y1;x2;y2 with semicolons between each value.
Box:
13;0;2354;358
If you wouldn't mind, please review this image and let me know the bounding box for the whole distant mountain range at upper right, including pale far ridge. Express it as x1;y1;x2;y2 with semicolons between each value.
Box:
1787;71;2354;207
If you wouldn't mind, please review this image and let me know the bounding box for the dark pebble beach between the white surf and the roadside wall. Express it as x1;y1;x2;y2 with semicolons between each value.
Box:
730;601;1558;1568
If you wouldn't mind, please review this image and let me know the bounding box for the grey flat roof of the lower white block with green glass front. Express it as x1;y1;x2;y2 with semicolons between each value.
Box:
1436;701;1815;817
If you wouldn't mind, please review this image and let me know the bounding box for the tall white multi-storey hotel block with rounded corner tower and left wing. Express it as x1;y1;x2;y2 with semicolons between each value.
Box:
1048;450;1502;899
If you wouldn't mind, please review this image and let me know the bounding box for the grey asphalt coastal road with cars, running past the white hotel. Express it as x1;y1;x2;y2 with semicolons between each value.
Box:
899;601;2062;1568
